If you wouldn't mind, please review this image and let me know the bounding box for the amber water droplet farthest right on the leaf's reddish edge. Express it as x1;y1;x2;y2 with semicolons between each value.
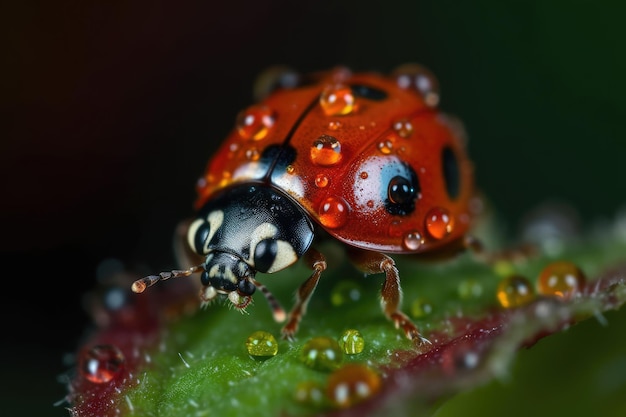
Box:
537;261;586;299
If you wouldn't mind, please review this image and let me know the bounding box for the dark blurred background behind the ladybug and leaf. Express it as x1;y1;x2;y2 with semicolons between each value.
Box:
0;0;626;416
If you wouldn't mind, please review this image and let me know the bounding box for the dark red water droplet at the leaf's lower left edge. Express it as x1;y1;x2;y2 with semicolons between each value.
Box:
80;345;124;384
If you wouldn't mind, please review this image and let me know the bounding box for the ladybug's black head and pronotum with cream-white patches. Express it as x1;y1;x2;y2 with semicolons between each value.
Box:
187;184;313;308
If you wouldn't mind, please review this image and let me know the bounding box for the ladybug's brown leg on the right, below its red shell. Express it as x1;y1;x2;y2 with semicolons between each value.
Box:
347;248;430;344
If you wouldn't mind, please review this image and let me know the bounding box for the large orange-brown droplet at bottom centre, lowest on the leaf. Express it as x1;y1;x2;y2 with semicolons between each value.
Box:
326;363;381;408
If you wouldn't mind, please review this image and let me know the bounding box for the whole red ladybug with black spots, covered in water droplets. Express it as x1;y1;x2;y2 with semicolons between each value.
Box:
132;64;474;341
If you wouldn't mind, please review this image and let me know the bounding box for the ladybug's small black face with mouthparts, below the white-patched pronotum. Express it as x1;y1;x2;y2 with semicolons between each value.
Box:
200;251;256;308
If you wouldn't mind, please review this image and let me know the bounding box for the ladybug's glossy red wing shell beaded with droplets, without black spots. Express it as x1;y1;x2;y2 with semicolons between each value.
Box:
196;70;474;253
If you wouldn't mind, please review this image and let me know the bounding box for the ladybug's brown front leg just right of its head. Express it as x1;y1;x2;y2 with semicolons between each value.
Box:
281;248;326;340
